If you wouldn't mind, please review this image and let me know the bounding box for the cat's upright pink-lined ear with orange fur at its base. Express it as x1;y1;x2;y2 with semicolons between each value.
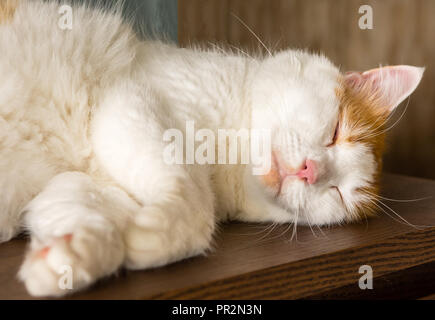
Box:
344;66;424;112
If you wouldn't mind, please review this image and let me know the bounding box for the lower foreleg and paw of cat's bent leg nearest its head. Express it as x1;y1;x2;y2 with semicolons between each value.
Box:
124;167;215;269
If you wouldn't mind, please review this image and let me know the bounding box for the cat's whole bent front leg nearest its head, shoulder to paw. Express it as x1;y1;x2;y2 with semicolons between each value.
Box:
92;84;215;269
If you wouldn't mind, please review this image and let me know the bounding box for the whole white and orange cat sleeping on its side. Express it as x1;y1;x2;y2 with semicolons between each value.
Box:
0;0;423;296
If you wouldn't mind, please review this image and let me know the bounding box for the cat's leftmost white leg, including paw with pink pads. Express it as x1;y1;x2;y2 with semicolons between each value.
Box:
19;172;138;296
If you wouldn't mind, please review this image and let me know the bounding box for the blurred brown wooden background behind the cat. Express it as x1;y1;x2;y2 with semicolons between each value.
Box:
178;0;435;179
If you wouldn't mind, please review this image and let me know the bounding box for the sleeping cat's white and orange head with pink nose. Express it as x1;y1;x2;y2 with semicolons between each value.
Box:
252;51;424;224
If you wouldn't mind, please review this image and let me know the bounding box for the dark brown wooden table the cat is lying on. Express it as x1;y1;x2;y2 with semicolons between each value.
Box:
0;174;435;299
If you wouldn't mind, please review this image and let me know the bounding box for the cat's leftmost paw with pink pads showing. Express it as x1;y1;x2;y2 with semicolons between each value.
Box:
18;231;124;297
